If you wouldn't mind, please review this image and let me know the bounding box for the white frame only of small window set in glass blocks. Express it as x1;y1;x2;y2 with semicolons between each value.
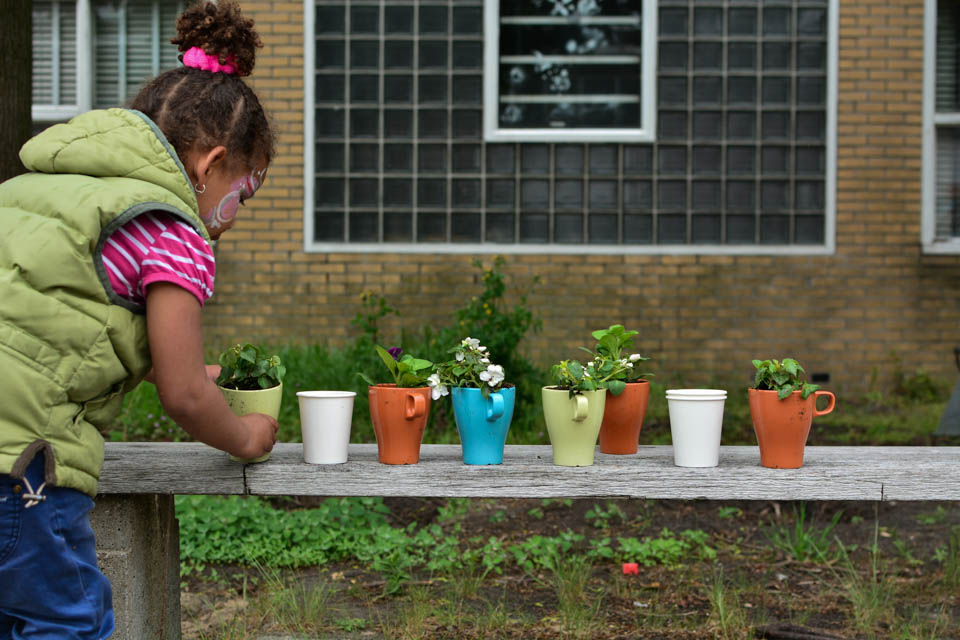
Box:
483;0;659;142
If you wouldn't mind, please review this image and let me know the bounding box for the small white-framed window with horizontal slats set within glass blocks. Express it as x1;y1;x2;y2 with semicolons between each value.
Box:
484;0;657;141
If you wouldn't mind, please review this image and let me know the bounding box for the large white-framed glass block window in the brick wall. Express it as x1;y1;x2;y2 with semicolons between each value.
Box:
305;0;836;253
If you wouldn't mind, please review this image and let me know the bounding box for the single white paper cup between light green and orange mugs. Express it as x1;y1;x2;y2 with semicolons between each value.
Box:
297;391;357;464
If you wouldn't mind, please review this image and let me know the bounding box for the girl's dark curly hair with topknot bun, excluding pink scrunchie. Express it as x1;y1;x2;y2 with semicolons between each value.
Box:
130;0;274;170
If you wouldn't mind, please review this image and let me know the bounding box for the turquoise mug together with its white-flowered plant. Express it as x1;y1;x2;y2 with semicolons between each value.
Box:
427;337;516;464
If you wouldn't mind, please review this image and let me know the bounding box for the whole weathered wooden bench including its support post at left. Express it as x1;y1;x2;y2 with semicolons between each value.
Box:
92;443;960;640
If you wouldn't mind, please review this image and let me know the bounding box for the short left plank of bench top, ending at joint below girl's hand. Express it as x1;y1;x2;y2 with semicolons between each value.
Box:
98;442;246;494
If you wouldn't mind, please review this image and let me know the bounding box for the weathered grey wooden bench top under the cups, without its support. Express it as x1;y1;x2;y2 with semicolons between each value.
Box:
101;443;960;500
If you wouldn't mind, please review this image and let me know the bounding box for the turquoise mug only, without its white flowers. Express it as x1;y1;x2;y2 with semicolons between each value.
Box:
450;387;517;464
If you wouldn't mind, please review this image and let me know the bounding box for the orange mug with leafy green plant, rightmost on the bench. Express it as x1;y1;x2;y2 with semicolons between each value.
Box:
747;358;837;469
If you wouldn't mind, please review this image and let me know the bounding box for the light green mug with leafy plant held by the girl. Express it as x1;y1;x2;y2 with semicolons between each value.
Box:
216;343;287;462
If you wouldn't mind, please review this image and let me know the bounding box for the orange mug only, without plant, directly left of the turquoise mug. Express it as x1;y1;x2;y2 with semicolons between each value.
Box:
369;384;430;464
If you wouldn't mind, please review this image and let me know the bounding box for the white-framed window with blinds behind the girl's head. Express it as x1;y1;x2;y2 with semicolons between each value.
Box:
33;0;186;122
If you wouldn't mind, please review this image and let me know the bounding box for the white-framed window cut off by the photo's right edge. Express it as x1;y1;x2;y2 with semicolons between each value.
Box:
922;0;960;253
